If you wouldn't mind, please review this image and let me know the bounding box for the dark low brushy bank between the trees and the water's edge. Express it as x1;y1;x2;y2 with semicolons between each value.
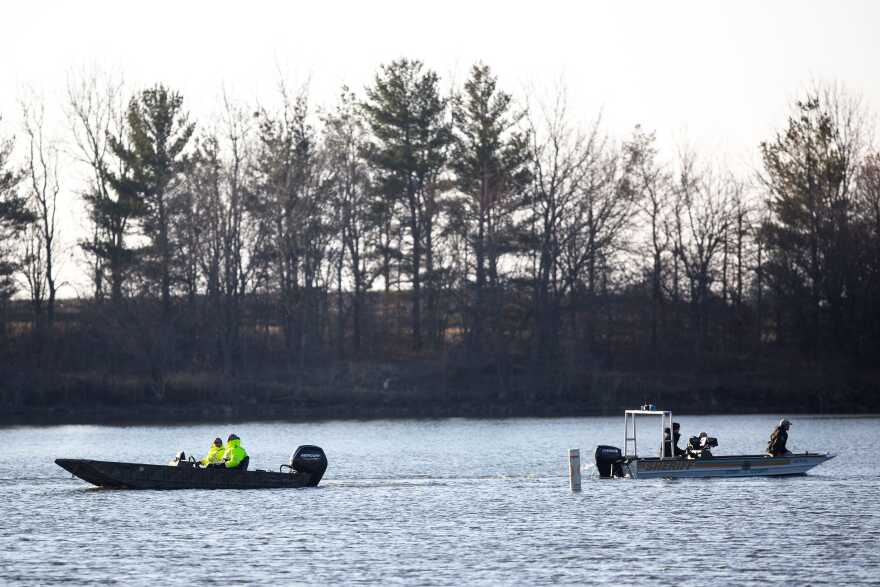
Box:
0;362;880;426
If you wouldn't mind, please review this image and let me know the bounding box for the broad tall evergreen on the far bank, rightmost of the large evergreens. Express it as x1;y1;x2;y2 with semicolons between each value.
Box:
761;95;853;353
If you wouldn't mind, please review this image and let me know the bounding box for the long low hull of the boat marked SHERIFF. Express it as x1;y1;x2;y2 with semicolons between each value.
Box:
624;453;834;479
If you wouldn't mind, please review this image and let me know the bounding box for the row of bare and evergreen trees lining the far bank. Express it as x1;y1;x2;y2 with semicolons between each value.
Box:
0;59;880;406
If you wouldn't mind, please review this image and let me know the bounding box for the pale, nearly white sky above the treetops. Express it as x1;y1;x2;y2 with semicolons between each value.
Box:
0;0;880;294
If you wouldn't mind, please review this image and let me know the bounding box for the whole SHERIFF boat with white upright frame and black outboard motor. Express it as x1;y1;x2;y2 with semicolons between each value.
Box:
596;405;835;479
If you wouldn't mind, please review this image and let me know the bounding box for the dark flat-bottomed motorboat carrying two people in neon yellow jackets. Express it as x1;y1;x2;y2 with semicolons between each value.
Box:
55;445;327;489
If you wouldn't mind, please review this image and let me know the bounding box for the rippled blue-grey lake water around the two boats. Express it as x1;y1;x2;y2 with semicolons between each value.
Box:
0;416;880;585
